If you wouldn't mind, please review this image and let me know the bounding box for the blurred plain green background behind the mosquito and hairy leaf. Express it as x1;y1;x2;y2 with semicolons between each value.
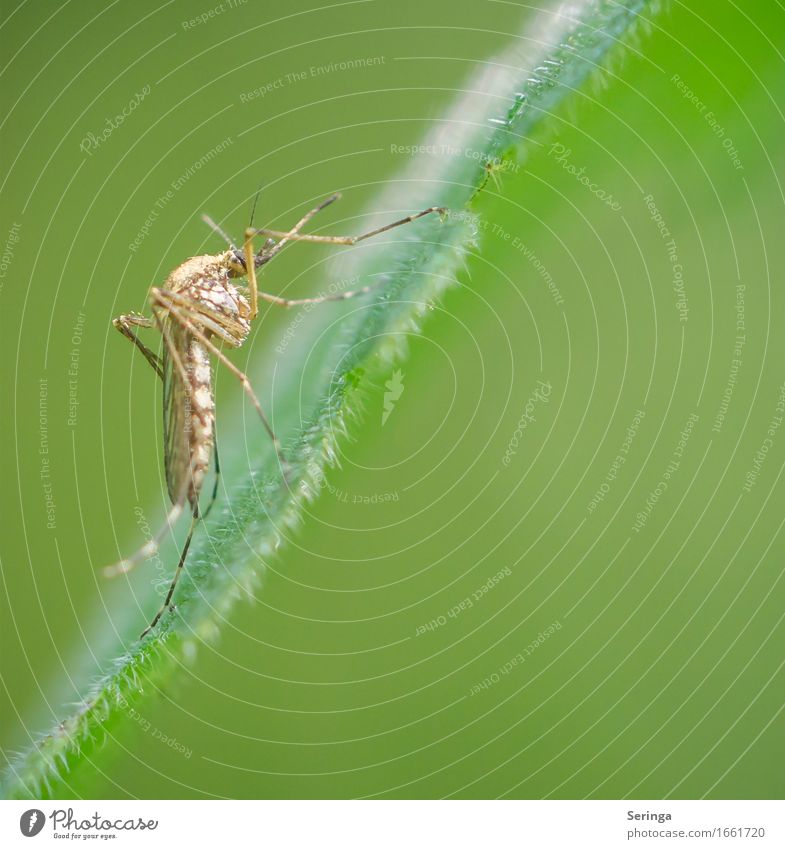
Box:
0;0;785;798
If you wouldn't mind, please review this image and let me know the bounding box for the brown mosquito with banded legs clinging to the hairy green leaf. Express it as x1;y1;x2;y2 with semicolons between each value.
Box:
104;187;447;639
